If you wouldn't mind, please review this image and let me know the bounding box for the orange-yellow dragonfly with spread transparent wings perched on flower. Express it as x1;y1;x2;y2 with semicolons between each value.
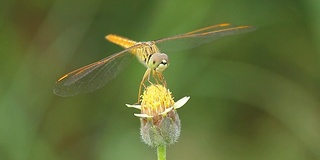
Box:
53;23;255;102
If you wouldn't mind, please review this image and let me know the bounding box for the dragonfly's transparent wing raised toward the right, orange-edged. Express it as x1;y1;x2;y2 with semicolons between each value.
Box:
154;23;255;53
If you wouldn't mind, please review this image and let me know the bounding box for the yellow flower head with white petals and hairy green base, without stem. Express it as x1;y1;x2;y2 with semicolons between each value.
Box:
127;84;190;147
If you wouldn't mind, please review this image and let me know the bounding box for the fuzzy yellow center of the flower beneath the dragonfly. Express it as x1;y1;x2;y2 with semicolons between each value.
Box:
141;85;174;116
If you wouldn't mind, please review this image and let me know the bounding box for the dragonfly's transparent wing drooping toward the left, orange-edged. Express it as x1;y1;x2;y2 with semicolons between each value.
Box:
53;47;133;97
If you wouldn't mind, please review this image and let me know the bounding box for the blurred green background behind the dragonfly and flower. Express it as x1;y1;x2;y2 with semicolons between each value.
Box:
0;0;320;160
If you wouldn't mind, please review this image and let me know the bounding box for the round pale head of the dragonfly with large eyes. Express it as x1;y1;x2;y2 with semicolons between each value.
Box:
148;53;169;73
